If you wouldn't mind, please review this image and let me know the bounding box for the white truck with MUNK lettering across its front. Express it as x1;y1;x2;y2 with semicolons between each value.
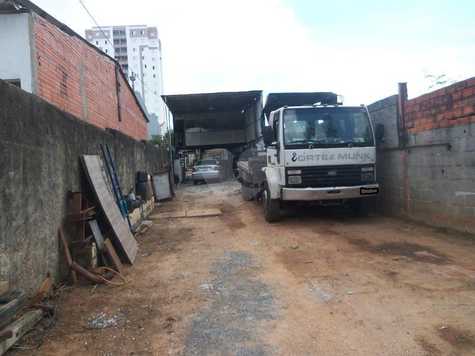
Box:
238;93;384;222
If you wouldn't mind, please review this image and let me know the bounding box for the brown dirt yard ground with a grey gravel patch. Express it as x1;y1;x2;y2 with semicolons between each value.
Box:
14;182;475;356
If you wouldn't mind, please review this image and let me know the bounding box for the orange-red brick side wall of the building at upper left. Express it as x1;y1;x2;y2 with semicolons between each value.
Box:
33;14;148;140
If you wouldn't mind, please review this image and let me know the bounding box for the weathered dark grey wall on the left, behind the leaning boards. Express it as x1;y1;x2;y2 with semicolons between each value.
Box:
0;80;166;292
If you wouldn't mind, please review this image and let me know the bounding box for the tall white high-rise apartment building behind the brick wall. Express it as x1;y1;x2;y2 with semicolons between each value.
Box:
86;25;167;137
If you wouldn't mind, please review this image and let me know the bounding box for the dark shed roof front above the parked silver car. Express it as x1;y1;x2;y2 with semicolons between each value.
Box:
162;90;262;115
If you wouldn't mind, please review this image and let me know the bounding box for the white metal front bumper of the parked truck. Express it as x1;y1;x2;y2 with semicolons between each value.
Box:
282;184;379;201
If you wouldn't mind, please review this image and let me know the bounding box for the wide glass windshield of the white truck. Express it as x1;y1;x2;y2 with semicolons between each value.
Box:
284;107;374;148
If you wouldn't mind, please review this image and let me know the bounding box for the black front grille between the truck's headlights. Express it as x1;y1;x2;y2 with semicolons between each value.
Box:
286;165;373;188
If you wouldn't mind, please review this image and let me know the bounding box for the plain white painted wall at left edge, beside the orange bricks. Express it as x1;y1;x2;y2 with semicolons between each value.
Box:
0;14;33;93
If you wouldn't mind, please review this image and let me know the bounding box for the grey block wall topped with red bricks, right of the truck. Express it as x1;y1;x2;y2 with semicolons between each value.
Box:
369;78;475;233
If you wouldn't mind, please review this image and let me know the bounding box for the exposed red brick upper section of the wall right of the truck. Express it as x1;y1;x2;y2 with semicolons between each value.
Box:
405;77;475;133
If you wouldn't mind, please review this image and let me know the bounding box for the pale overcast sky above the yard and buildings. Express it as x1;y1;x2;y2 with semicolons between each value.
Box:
33;0;475;105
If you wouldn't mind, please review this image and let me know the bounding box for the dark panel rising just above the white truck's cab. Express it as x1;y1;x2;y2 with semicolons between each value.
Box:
264;92;337;117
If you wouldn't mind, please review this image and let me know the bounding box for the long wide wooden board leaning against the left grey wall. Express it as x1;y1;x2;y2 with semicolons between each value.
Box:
81;155;137;263
